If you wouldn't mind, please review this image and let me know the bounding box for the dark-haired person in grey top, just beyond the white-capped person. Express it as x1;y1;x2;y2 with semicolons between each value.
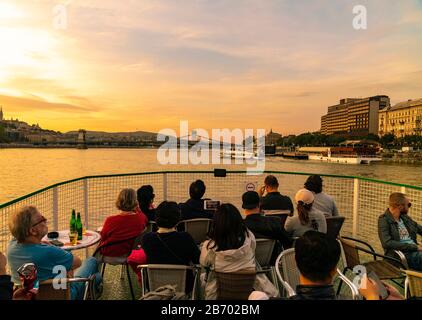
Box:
305;175;339;218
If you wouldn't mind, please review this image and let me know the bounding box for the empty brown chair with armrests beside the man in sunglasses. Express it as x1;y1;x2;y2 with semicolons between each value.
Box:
337;237;406;294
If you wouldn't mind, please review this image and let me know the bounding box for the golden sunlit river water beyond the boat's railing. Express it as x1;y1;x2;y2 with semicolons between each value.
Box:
0;149;422;203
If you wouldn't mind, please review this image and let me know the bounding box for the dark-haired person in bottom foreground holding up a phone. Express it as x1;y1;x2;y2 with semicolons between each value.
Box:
249;231;403;300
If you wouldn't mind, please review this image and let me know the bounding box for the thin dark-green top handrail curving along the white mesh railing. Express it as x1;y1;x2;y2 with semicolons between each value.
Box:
0;170;422;209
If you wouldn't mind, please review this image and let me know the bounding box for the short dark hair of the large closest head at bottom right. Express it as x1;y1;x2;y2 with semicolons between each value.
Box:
295;231;340;282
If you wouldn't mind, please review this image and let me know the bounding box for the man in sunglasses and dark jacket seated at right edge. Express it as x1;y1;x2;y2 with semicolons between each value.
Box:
378;192;422;271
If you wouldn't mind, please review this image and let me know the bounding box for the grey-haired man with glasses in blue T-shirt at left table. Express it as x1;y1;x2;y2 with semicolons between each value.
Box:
7;206;102;300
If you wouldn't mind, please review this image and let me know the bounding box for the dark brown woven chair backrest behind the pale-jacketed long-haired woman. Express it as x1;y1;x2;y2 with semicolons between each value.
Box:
215;271;256;300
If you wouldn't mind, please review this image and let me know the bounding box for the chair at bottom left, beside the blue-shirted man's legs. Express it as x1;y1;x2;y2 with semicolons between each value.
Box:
35;275;97;300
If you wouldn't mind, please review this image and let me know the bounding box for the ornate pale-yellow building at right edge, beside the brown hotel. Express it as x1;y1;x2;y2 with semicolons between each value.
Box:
379;99;422;138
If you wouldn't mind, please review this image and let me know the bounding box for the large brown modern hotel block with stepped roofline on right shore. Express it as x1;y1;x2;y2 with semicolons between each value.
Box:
321;95;390;136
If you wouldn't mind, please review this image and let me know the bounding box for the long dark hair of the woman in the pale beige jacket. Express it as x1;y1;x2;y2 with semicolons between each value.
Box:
207;203;248;251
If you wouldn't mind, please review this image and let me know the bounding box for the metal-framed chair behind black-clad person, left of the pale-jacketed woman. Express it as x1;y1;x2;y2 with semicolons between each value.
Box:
138;264;198;300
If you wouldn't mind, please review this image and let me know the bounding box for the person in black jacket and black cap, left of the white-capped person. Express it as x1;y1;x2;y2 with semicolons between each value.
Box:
242;191;292;263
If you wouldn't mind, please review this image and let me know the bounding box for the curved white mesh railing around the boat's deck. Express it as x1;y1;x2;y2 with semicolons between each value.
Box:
0;171;422;252
